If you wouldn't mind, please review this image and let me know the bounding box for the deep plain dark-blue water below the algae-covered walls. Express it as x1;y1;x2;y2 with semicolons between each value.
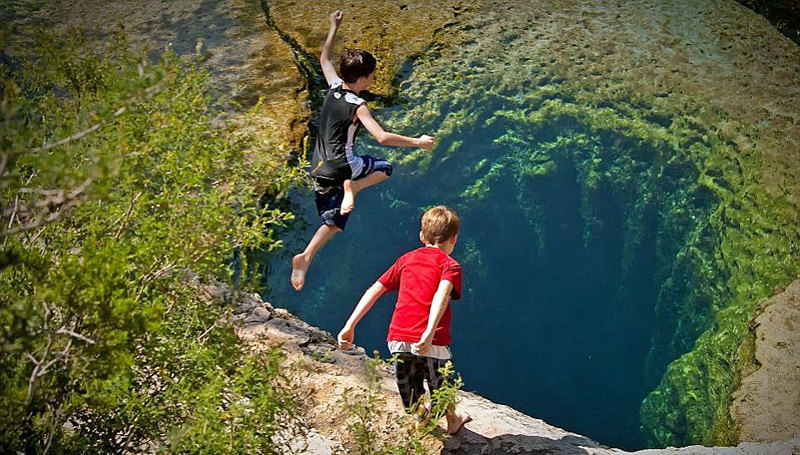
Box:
268;122;658;449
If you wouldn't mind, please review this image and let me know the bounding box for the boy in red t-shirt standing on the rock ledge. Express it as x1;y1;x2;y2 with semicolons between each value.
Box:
338;205;471;434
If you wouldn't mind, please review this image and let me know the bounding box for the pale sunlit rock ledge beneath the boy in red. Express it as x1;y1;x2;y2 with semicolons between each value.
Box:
208;284;800;455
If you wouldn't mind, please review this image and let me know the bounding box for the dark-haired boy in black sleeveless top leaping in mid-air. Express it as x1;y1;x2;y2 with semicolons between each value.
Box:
291;10;434;291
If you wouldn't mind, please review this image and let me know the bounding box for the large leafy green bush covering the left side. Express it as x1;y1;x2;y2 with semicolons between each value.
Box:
0;27;300;453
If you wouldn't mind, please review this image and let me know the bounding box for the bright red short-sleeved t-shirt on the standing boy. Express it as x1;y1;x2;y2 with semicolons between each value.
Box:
378;247;461;346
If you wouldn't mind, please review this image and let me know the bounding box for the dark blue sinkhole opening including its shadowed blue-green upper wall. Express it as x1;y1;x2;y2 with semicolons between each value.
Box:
268;111;714;449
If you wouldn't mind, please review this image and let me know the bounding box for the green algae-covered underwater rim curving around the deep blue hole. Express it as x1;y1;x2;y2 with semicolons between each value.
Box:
268;0;800;446
